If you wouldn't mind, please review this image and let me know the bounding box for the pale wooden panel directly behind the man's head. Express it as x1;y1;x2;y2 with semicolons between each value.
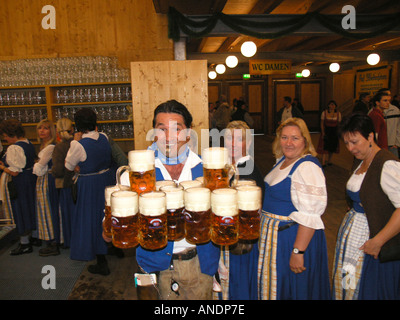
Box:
131;60;208;152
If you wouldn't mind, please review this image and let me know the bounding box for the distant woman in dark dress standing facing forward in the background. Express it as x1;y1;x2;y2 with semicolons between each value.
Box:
317;100;342;168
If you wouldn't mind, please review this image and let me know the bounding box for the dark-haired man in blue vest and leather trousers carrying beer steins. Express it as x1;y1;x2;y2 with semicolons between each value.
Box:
121;100;220;300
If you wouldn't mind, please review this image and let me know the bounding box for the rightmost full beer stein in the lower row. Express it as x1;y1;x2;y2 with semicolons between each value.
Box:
236;186;262;240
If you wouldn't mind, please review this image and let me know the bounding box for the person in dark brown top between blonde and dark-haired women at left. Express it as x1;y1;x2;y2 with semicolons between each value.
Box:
51;118;75;248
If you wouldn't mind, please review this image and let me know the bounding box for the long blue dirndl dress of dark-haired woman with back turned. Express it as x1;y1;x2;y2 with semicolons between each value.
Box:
70;134;113;261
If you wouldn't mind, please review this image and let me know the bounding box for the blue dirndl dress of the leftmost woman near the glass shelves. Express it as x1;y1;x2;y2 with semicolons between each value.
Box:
11;141;36;235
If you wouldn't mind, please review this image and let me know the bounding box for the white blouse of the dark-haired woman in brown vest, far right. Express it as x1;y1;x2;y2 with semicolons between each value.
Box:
346;160;400;208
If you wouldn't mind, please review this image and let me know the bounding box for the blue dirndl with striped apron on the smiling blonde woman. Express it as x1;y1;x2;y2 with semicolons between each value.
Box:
258;156;330;300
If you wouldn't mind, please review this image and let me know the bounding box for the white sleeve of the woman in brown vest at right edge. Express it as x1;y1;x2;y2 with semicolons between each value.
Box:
381;160;400;208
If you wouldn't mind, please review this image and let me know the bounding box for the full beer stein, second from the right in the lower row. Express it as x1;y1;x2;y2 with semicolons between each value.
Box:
211;188;239;246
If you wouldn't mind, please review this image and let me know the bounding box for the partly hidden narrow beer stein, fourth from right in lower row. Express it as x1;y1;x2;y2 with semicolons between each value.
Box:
160;186;185;241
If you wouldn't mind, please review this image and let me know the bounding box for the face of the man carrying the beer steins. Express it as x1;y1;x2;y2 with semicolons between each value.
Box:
155;113;190;158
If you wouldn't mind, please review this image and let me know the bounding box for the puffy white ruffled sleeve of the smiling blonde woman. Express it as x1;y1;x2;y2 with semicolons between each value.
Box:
289;161;328;229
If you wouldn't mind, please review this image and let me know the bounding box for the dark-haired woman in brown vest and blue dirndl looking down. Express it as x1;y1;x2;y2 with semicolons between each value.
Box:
333;114;400;300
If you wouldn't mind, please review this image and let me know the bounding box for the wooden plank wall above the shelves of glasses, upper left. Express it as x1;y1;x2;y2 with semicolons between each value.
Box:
0;0;173;68
